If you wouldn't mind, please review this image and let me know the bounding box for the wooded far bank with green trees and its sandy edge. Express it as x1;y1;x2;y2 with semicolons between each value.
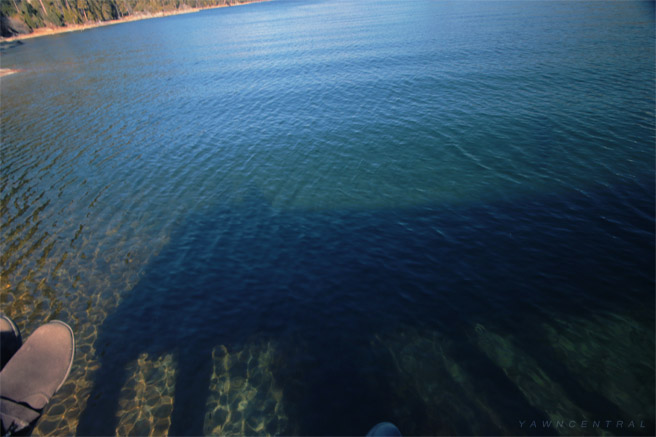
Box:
0;0;263;41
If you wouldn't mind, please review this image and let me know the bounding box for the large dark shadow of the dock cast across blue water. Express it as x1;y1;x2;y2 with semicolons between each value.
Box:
77;182;651;435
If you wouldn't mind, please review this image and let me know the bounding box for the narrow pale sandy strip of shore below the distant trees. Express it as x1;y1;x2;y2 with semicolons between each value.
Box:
0;0;269;42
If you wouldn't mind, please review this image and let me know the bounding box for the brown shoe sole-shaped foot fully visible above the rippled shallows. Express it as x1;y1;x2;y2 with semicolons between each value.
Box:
0;320;75;435
